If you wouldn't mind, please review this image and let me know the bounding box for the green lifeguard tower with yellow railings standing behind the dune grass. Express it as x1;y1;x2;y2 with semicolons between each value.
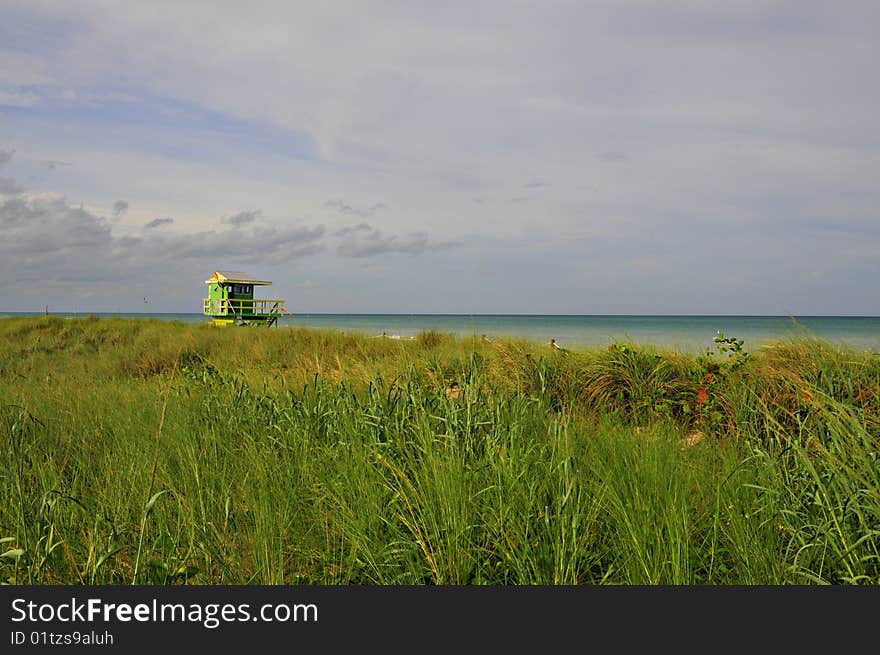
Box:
202;271;290;327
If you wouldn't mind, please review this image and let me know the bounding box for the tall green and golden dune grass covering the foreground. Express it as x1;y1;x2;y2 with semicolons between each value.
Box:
0;317;880;585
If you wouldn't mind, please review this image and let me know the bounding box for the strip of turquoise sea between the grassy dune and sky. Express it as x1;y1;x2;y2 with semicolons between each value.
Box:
0;312;880;353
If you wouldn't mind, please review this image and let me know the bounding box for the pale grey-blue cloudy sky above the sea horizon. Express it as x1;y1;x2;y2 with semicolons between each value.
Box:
0;0;880;316
